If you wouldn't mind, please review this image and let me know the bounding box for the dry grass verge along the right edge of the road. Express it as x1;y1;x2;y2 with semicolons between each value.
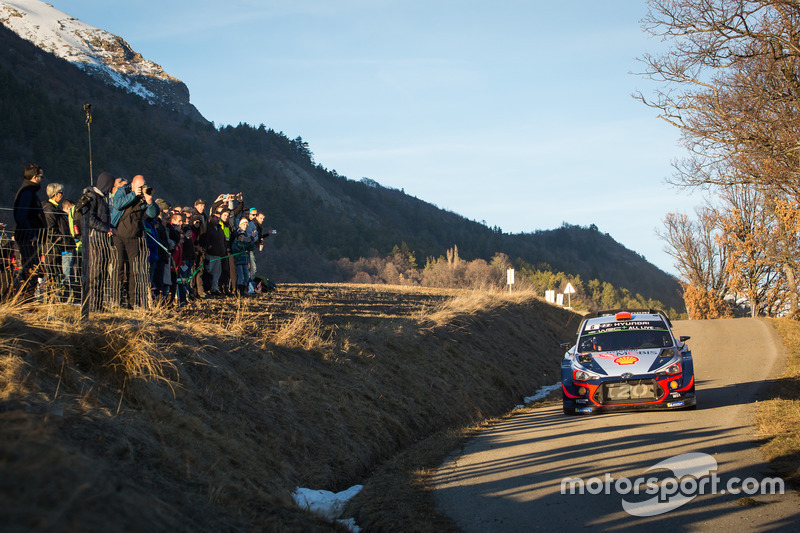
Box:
756;319;800;487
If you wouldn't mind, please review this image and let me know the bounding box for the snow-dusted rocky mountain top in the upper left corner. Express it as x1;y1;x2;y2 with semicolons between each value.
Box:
0;0;199;115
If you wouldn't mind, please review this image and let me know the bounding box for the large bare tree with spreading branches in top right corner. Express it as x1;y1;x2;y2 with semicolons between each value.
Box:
637;0;800;197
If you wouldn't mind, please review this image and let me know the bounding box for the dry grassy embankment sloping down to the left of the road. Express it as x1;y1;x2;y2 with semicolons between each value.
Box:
0;285;578;531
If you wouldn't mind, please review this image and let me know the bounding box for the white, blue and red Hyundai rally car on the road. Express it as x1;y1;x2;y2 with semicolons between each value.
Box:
561;309;696;415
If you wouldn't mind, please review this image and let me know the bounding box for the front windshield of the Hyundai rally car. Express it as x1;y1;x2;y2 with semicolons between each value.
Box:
578;322;673;353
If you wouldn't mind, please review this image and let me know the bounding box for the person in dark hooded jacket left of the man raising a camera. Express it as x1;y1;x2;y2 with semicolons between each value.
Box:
82;172;119;311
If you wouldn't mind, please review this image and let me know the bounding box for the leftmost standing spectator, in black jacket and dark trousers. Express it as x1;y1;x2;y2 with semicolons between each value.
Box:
14;163;45;291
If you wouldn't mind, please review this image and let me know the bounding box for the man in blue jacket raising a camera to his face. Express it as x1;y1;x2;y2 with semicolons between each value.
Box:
110;175;159;308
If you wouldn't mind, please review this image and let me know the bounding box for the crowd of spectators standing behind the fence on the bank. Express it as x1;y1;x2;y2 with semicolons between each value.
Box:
3;165;274;310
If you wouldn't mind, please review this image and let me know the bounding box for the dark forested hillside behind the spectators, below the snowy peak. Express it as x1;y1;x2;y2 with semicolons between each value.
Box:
0;23;683;309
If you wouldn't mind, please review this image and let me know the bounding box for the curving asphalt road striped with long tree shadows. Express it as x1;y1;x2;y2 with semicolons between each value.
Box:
435;319;800;533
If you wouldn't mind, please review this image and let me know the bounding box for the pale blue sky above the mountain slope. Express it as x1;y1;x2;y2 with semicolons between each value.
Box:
51;0;701;272
